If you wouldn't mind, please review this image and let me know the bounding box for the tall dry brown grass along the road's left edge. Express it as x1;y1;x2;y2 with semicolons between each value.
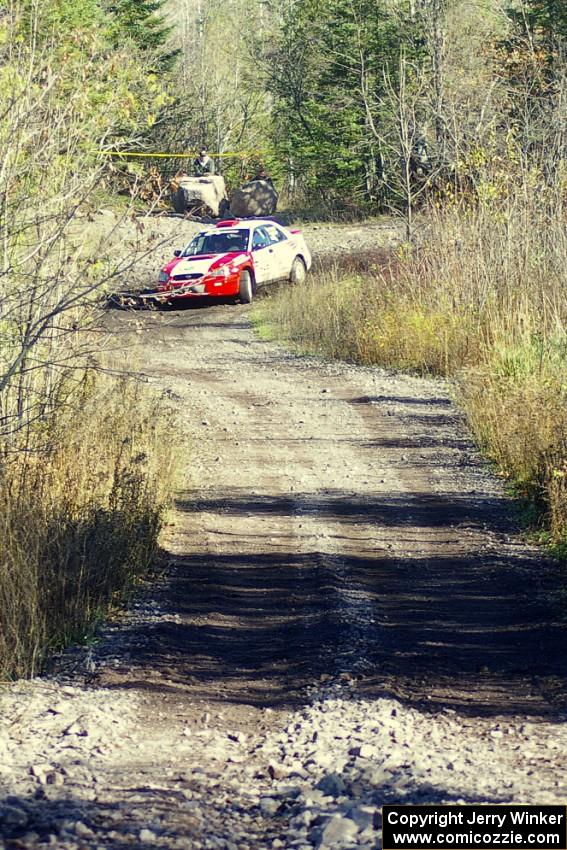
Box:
0;375;176;679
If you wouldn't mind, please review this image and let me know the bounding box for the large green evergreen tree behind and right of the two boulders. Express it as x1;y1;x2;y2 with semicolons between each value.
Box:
267;0;420;209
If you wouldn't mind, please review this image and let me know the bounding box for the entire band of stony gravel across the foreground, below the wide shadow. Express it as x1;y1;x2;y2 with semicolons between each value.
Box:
4;673;567;850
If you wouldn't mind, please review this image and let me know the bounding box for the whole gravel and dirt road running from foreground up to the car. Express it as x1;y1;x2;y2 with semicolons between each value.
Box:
0;227;567;850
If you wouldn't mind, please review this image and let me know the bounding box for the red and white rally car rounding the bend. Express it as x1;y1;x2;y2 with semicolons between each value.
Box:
157;219;311;304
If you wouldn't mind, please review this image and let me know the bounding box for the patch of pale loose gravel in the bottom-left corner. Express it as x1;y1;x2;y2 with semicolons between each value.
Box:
0;679;137;847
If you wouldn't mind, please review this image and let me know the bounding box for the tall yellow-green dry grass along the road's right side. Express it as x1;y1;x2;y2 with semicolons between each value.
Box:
254;204;567;549
